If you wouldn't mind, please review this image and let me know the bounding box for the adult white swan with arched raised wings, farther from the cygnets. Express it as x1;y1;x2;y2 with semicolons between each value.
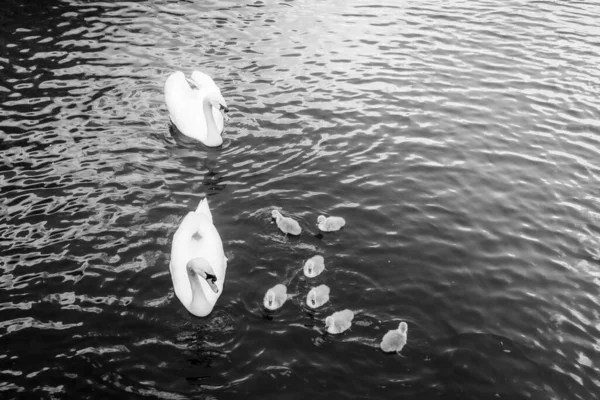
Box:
165;71;229;147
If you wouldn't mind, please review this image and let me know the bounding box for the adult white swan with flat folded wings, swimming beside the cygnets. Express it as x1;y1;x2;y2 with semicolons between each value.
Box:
169;199;227;317
